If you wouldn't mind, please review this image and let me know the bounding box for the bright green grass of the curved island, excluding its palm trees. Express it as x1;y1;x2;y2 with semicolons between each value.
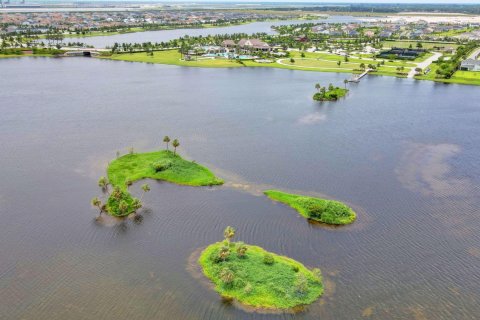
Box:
107;150;223;190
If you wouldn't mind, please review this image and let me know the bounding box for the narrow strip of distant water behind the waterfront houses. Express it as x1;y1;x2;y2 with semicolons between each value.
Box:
64;16;361;48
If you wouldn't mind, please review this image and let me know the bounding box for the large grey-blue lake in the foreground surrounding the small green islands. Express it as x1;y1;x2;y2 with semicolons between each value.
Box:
0;58;480;320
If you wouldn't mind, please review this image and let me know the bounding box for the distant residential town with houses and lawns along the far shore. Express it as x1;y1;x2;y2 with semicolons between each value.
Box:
0;3;480;84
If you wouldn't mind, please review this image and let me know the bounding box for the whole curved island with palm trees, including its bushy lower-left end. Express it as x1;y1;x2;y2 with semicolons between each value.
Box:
91;136;223;217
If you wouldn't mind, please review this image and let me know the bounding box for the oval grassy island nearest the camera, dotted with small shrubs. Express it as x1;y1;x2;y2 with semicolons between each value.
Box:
199;227;323;310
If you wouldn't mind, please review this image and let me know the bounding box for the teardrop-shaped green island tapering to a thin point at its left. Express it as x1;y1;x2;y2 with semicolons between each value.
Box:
264;190;356;225
